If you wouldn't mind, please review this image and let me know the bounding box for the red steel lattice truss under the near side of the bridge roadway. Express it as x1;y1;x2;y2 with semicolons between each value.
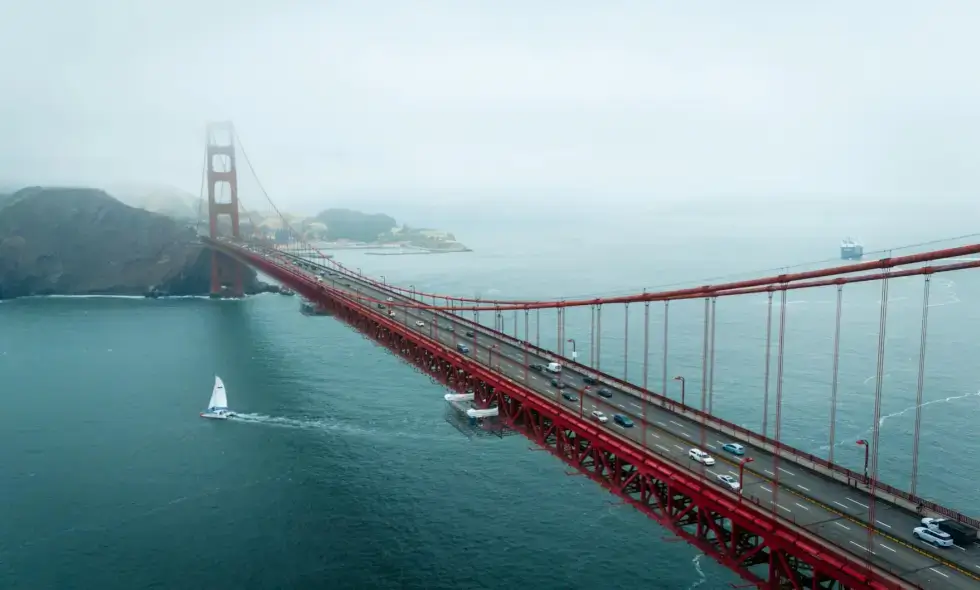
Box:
211;242;909;589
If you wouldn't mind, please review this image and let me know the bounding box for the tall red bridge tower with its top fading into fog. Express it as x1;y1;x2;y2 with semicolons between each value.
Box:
207;121;244;297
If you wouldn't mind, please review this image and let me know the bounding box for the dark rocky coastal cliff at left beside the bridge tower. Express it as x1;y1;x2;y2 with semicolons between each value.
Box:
0;187;276;299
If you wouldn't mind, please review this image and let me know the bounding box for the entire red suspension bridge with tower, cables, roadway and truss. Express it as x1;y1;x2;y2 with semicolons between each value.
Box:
202;124;980;589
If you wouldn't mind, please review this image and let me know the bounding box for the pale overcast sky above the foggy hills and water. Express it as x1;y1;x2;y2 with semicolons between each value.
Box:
0;0;980;213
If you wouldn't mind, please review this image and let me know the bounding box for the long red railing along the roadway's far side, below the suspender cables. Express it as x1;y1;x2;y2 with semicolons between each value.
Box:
245;243;980;528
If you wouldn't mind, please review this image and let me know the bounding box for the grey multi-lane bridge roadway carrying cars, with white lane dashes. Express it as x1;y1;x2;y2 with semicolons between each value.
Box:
264;249;980;590
